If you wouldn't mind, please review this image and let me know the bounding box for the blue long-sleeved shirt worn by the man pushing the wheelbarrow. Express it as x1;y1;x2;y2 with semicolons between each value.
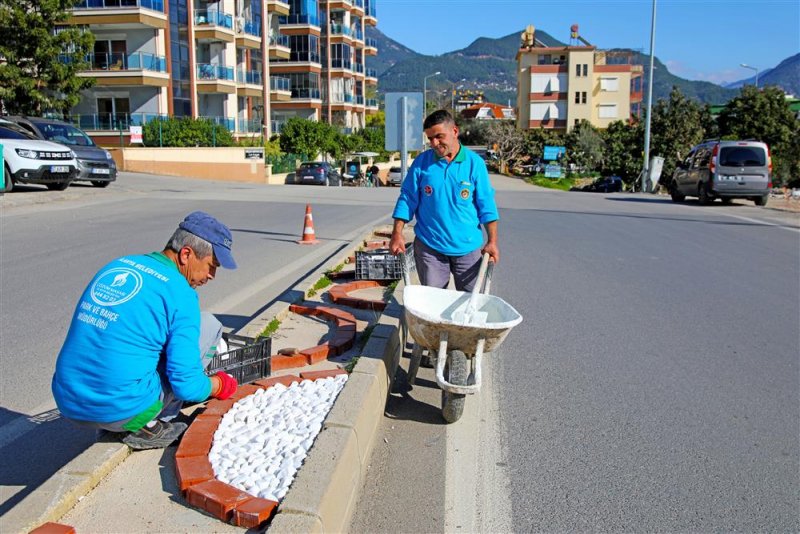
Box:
392;145;499;256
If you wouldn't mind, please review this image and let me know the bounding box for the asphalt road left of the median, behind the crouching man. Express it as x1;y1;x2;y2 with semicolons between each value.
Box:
0;177;397;515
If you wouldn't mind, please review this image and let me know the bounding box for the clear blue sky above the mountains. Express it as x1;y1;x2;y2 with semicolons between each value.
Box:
377;0;800;84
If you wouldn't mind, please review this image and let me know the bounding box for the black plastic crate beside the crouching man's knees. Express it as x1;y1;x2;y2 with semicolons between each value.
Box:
206;334;272;384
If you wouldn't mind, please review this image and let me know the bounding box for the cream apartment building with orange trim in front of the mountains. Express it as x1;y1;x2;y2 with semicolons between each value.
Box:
517;26;643;131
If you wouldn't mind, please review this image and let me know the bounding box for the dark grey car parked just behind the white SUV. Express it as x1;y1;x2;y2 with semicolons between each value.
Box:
6;116;117;187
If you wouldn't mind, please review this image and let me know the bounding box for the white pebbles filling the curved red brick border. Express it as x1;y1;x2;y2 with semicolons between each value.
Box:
208;374;347;502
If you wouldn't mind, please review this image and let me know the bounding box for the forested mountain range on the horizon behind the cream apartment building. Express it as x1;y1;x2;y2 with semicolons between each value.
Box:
367;28;788;106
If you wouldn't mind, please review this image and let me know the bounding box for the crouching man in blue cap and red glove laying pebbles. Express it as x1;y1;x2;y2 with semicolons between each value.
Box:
52;211;237;449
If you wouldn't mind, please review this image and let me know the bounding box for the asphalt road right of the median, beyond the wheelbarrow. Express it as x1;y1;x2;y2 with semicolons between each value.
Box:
351;177;800;532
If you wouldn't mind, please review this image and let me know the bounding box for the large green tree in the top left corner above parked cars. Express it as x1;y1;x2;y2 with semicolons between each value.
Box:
0;0;94;115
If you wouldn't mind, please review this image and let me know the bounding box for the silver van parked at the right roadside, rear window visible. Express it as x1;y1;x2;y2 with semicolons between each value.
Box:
667;140;772;206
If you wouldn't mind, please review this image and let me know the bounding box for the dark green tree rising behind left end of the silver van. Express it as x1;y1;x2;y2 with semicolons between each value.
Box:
650;87;705;183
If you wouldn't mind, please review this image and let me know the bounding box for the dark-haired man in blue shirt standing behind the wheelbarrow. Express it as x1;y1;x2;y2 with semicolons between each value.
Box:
389;110;500;291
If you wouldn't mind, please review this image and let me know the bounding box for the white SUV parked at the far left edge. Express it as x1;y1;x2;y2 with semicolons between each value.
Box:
0;122;78;193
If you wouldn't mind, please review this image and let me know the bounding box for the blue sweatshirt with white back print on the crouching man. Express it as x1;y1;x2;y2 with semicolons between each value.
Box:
52;252;211;423
